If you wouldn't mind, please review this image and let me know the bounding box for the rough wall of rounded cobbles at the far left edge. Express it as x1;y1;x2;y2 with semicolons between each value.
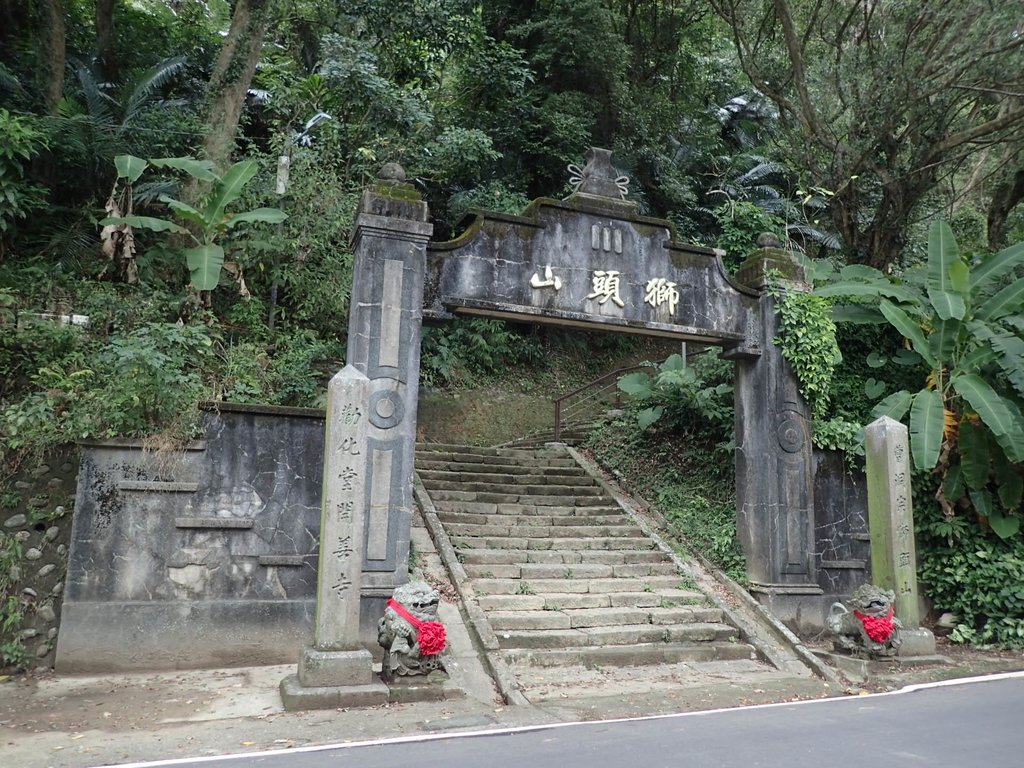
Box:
0;447;78;667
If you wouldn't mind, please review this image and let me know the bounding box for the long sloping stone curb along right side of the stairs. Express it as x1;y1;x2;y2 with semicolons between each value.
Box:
565;445;842;685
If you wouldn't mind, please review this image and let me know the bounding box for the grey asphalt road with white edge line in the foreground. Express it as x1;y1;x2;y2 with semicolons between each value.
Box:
116;674;1024;768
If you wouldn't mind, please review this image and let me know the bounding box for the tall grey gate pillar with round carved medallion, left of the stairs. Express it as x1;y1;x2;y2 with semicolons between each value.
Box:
347;163;433;593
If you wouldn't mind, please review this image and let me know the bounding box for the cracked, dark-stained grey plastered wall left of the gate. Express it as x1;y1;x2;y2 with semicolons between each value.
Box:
56;404;348;672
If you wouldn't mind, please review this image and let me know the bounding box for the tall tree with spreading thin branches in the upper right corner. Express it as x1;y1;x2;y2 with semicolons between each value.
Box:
711;0;1024;268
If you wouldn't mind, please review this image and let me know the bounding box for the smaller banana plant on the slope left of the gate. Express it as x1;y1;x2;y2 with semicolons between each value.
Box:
99;155;288;291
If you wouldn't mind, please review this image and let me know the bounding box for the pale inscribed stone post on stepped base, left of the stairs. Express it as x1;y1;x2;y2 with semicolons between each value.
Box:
281;366;388;711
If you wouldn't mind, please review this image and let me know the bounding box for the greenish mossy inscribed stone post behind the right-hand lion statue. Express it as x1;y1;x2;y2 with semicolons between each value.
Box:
864;416;935;656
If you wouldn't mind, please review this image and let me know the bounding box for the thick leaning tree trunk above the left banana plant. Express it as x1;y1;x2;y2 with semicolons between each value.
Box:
197;0;273;172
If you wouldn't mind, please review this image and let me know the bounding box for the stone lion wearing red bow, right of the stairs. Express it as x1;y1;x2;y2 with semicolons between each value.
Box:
826;584;903;657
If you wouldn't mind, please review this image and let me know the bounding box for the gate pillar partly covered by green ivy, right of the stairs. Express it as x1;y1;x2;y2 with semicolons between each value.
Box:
734;244;824;632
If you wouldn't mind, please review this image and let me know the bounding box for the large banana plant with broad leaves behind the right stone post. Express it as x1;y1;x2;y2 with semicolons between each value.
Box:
815;221;1024;538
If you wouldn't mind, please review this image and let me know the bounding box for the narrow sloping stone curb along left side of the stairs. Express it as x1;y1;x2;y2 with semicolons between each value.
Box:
413;472;529;706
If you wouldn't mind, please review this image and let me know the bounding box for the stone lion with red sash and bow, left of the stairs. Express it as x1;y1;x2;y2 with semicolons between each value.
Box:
377;582;447;680
